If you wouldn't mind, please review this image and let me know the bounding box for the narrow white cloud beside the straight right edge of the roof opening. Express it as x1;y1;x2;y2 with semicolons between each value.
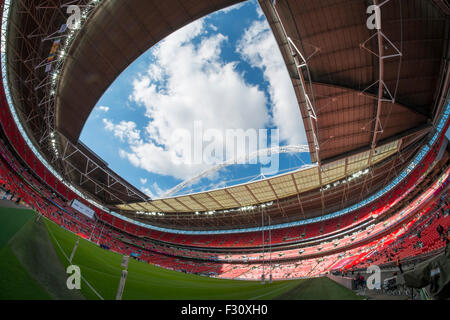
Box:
237;18;306;144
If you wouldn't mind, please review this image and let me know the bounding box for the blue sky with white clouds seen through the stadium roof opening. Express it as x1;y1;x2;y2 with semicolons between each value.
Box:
81;1;310;198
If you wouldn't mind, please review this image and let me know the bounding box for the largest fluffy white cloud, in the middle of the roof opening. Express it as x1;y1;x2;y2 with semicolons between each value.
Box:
122;19;270;179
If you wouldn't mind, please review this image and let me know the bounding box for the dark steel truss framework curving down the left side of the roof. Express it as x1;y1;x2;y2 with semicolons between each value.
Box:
2;0;153;203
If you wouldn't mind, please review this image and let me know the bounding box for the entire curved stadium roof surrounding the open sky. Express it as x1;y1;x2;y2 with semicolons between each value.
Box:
7;0;449;227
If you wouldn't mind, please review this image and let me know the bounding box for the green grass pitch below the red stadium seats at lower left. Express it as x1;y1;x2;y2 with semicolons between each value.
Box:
0;208;359;300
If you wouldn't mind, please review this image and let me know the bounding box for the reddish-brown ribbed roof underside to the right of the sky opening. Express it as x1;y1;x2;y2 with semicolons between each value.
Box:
272;0;448;161
